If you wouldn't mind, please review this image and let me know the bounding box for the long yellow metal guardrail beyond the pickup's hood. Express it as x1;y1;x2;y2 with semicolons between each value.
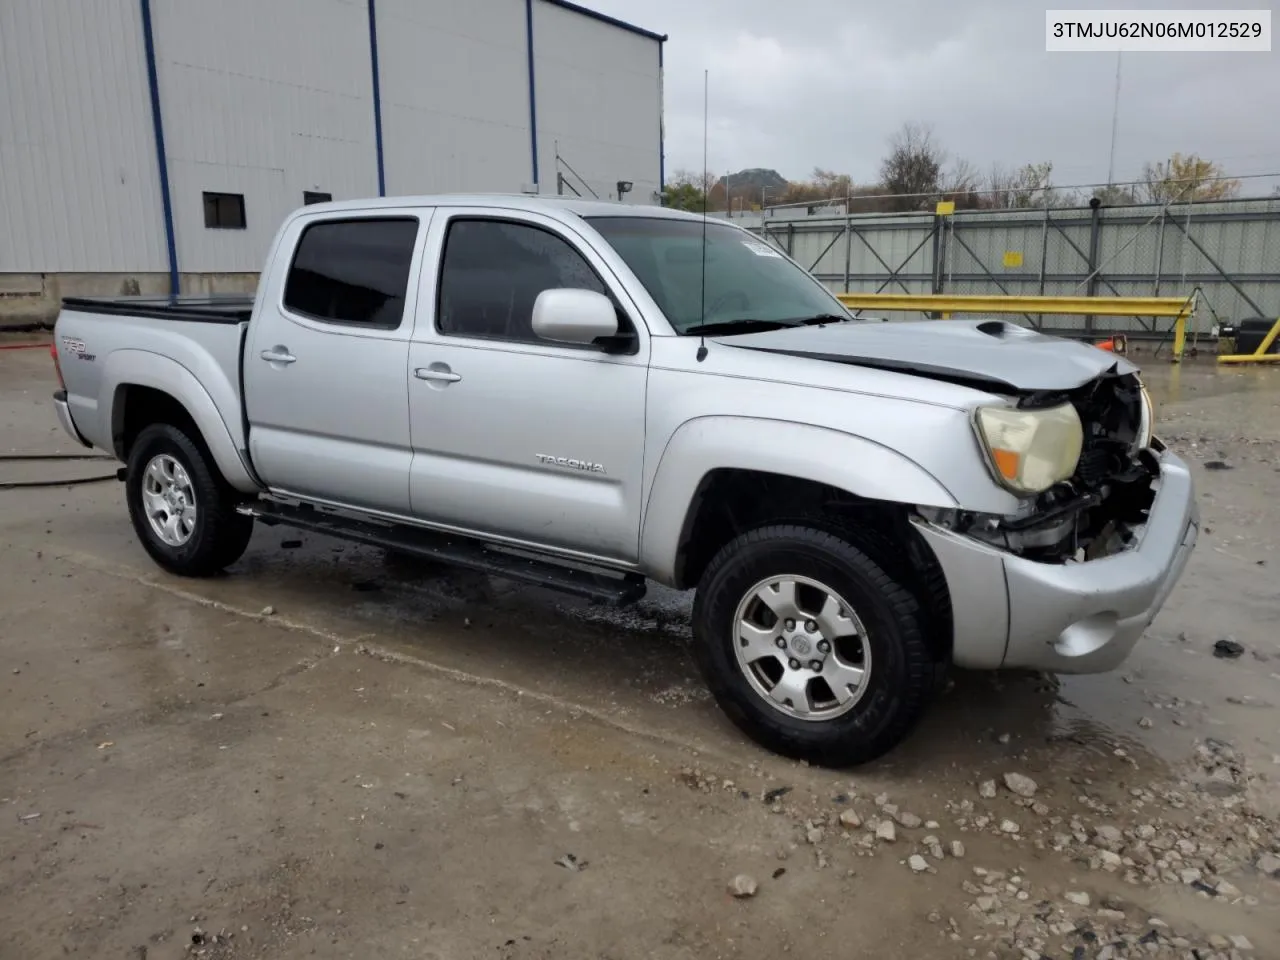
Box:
836;293;1192;364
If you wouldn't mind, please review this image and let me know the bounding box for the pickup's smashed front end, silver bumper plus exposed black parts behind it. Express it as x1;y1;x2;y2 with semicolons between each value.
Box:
914;374;1199;673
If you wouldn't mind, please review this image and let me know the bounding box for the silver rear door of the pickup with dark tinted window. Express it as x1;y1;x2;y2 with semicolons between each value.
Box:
244;210;430;515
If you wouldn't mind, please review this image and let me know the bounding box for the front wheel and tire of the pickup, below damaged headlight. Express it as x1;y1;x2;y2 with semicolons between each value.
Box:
694;525;934;767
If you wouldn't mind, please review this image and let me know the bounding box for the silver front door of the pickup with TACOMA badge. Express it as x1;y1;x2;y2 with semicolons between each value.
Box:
408;209;649;562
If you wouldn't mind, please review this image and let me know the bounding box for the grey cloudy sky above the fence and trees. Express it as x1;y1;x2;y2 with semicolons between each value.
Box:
584;0;1280;193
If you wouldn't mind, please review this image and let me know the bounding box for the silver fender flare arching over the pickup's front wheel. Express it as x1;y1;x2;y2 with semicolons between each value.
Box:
640;416;957;584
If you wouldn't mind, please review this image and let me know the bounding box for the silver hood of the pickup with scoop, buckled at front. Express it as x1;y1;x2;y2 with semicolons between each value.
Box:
716;320;1138;393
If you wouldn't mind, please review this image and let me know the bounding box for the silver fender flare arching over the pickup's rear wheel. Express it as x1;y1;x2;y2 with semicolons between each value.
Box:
97;349;259;493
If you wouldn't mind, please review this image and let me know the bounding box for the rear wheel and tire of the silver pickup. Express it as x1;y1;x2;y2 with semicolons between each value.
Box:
124;424;253;577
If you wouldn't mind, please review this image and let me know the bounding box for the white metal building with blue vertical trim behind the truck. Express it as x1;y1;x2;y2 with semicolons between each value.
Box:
0;0;666;317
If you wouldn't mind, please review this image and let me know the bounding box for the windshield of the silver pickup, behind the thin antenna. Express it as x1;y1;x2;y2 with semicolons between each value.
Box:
588;216;852;334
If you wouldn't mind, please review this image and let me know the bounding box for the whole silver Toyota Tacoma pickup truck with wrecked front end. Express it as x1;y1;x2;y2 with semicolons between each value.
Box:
55;196;1198;765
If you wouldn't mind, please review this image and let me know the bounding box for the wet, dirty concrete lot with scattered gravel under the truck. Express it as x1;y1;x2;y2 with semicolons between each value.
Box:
0;349;1280;960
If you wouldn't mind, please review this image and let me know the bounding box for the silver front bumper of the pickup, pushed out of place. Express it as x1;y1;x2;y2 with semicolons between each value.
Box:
914;449;1199;673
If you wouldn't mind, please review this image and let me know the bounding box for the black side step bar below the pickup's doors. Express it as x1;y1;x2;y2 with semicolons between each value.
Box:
238;500;645;605
